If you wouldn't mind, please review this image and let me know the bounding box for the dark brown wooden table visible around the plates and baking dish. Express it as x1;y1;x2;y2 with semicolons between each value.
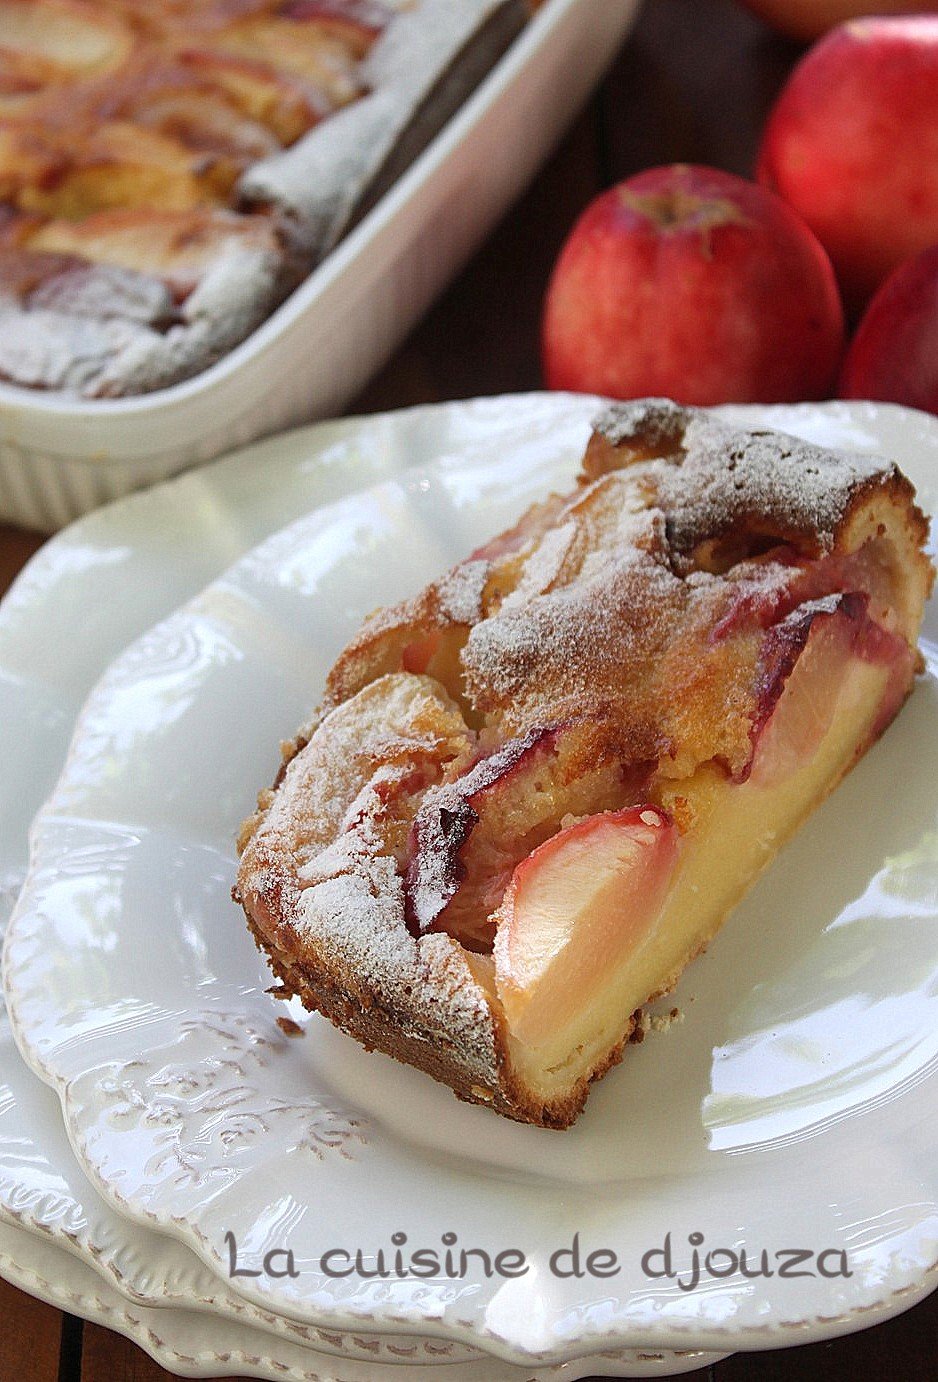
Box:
0;0;938;1382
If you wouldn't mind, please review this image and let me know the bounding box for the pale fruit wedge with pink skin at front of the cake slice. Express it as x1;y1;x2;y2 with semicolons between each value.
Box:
495;806;678;1046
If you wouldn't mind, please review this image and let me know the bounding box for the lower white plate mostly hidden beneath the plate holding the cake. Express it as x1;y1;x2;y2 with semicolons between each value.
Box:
0;398;704;1378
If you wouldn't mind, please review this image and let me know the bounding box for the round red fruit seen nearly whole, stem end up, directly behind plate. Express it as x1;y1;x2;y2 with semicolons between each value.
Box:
543;164;844;404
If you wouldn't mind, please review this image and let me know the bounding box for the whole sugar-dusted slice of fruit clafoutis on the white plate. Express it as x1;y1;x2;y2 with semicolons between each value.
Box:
235;401;932;1128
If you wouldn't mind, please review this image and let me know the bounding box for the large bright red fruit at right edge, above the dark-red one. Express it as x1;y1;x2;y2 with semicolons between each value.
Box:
758;14;938;307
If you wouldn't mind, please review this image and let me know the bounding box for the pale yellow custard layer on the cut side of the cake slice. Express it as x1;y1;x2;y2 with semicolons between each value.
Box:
496;621;908;1101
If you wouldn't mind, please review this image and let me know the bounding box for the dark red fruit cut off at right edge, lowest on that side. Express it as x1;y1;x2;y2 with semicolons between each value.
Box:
840;245;938;413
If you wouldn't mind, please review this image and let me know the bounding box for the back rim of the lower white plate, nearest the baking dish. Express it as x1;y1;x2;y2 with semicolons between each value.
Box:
0;394;594;920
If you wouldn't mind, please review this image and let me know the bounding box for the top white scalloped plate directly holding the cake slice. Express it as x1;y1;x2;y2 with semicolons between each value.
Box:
7;399;938;1361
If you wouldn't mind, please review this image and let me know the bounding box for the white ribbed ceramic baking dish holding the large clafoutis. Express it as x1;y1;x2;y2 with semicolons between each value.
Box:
0;0;638;531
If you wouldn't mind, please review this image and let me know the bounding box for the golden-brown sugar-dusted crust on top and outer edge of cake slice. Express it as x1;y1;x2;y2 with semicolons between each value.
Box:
238;401;932;1128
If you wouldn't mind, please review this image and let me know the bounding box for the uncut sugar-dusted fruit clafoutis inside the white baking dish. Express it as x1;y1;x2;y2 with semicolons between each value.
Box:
0;0;533;398
